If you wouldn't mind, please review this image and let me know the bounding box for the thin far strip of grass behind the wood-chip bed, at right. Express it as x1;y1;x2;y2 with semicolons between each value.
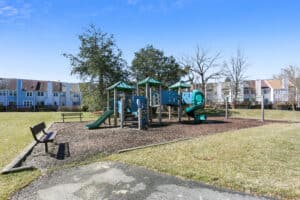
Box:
229;109;300;121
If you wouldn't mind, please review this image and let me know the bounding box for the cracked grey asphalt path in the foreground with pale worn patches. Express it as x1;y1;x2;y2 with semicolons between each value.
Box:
12;162;265;200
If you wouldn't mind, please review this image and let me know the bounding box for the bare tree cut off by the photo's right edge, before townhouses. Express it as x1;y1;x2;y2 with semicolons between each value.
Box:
274;65;300;110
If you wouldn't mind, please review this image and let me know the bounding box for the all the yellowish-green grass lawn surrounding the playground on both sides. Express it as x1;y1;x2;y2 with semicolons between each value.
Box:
0;110;300;199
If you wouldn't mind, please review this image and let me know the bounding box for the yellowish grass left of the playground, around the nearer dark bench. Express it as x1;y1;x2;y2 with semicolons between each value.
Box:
0;112;95;199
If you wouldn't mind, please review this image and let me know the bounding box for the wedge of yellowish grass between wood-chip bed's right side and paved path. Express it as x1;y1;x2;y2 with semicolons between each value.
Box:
108;124;300;199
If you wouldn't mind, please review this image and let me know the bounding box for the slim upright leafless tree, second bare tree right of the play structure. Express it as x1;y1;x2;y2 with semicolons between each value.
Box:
223;49;247;107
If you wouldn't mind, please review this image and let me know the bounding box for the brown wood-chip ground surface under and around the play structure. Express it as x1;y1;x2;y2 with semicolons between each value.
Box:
23;117;271;168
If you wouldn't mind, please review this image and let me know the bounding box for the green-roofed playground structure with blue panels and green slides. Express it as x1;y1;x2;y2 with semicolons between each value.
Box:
86;77;206;129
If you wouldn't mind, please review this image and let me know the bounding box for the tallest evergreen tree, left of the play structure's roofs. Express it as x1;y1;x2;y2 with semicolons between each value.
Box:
63;25;128;110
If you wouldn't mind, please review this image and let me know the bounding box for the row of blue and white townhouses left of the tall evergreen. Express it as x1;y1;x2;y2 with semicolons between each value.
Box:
0;78;81;108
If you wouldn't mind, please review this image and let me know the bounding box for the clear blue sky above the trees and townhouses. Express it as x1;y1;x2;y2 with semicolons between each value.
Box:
0;0;300;82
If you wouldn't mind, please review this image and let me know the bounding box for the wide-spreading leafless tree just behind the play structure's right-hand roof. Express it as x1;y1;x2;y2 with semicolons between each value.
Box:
183;46;222;95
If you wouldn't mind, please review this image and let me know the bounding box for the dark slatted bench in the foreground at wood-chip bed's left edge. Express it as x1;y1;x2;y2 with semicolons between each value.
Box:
30;122;57;153
